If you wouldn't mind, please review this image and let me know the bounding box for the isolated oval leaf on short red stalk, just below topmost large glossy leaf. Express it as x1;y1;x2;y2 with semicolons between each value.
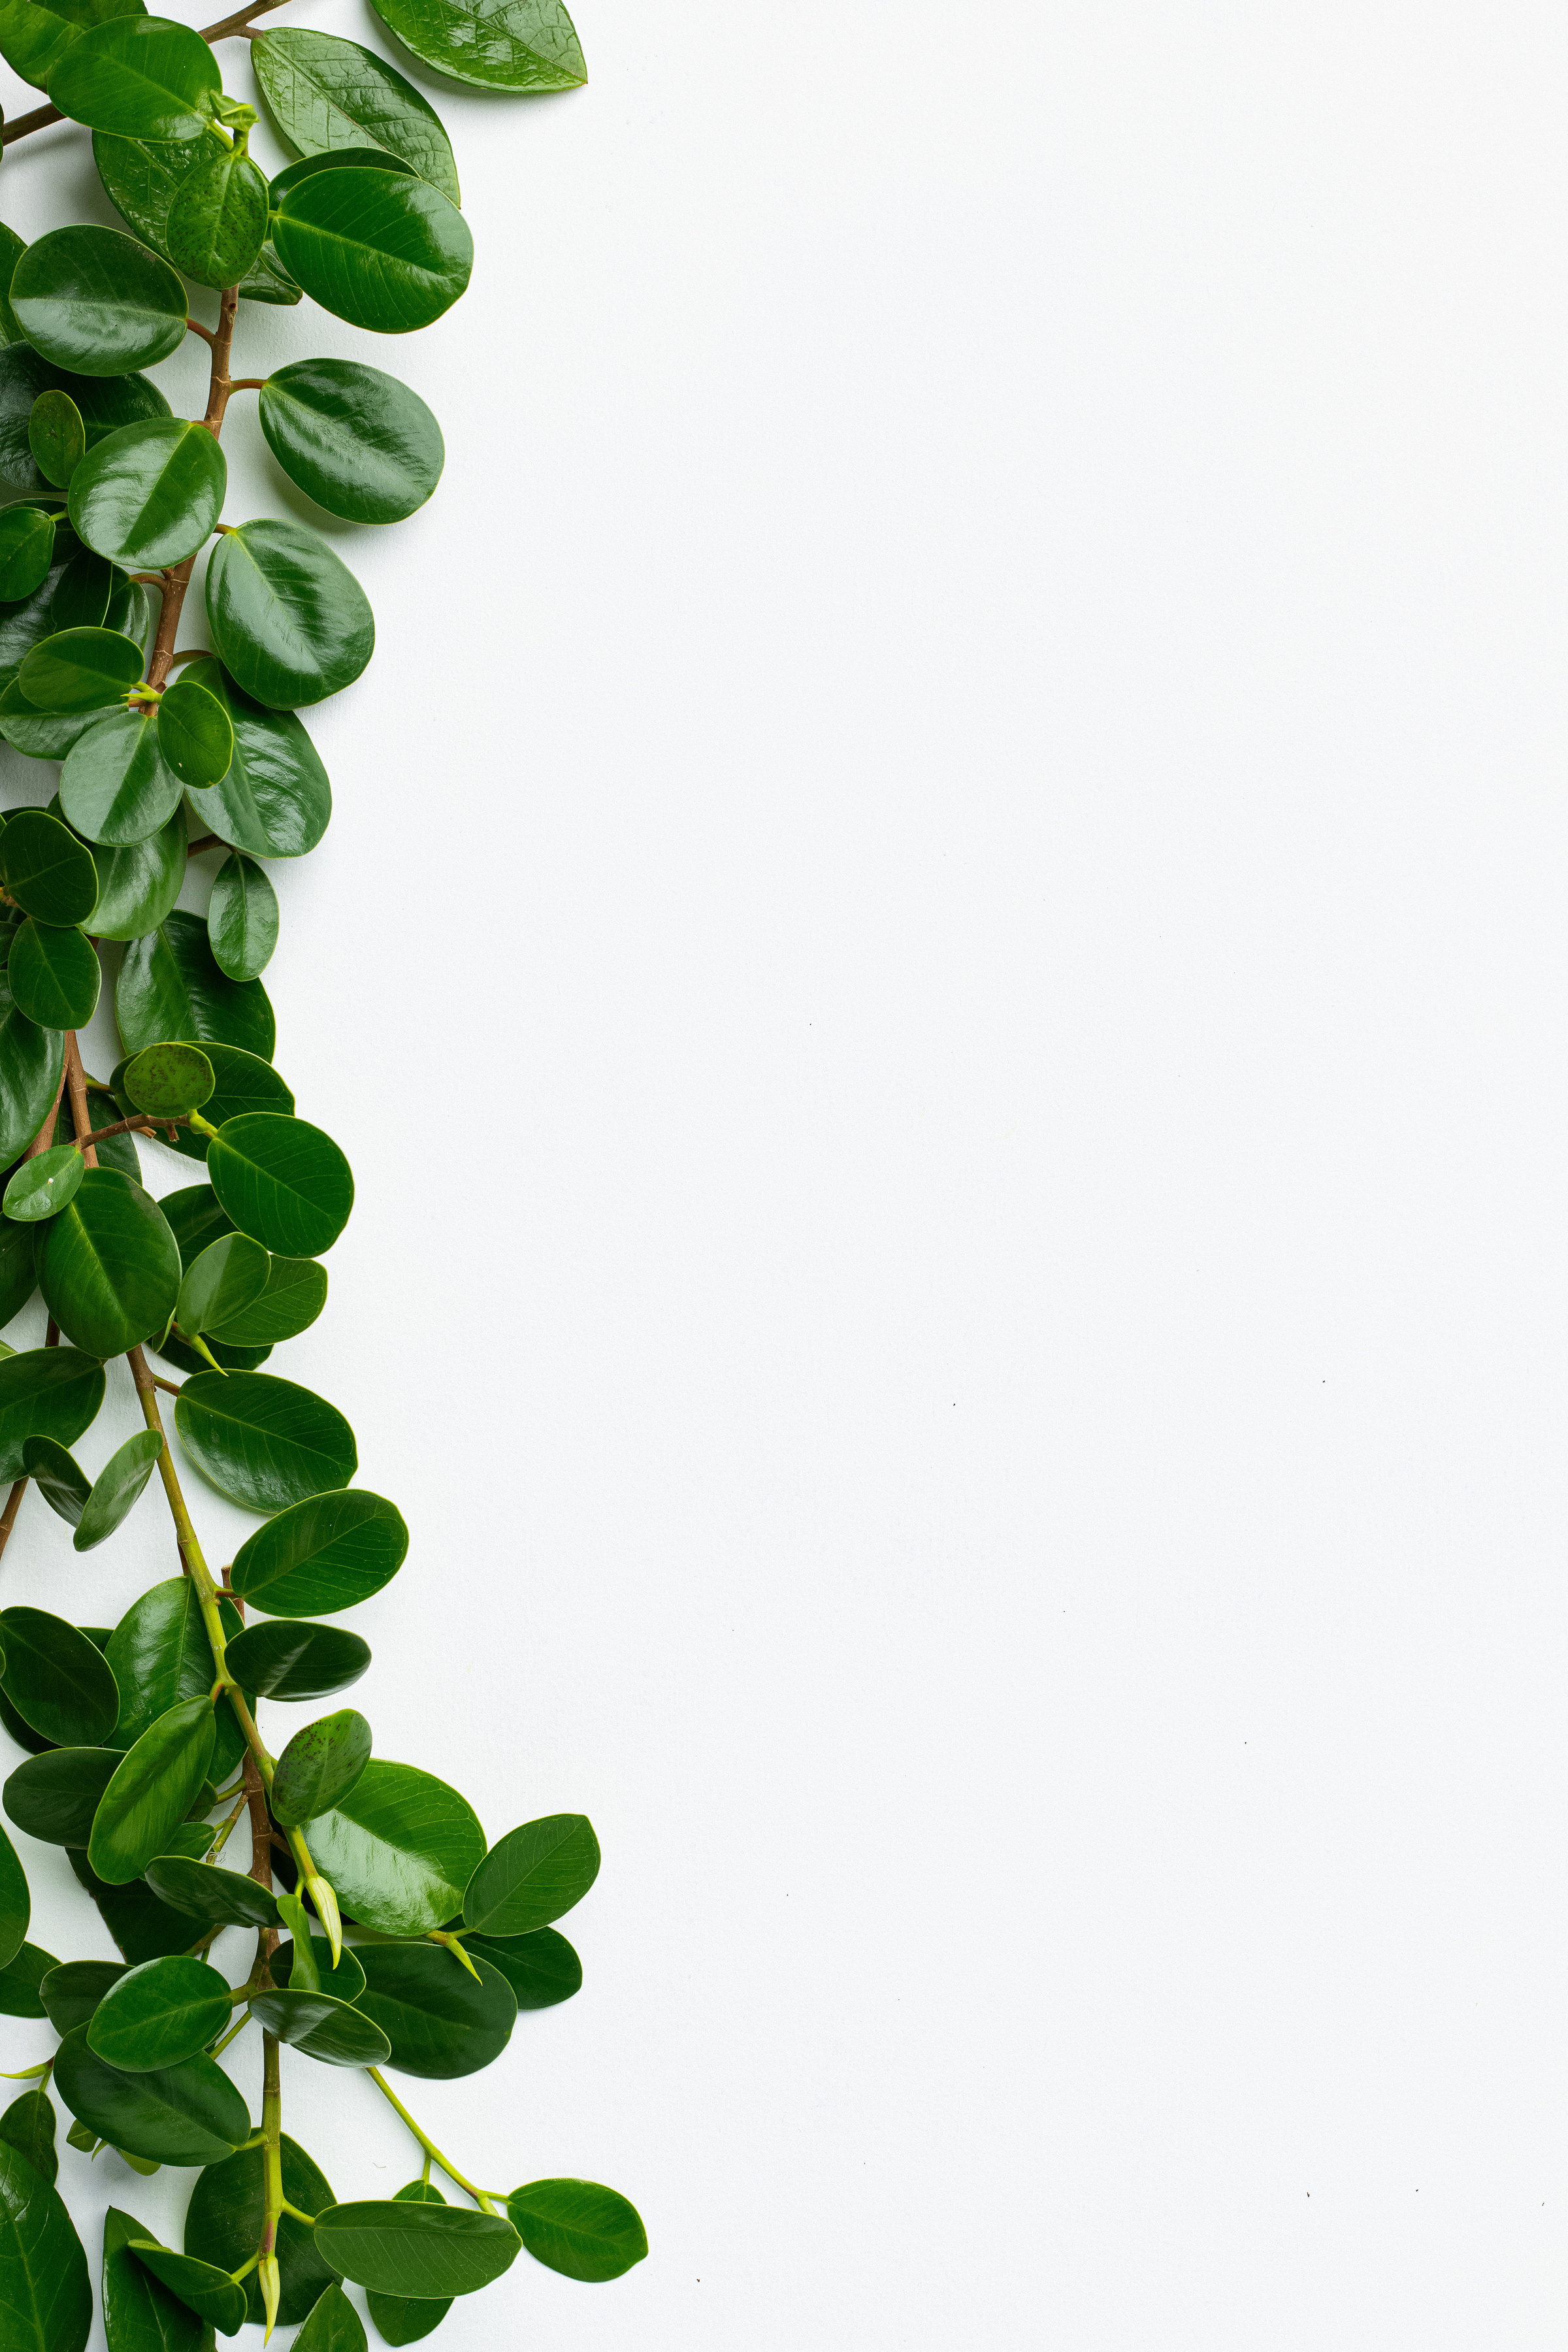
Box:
261;357;447;522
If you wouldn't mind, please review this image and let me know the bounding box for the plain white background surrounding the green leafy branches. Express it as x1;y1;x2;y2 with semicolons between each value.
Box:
0;0;1568;2352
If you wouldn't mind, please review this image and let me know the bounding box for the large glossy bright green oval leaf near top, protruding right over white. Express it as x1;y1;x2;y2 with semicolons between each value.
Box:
270;167;472;336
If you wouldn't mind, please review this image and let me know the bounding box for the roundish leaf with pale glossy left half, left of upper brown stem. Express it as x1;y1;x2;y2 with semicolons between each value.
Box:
69;418;233;574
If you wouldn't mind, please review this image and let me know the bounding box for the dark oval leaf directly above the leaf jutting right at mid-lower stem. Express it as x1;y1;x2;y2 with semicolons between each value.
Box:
175;1364;360;1512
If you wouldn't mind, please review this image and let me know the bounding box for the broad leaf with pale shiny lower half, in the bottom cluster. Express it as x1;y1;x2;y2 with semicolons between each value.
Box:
308;1757;484;1929
